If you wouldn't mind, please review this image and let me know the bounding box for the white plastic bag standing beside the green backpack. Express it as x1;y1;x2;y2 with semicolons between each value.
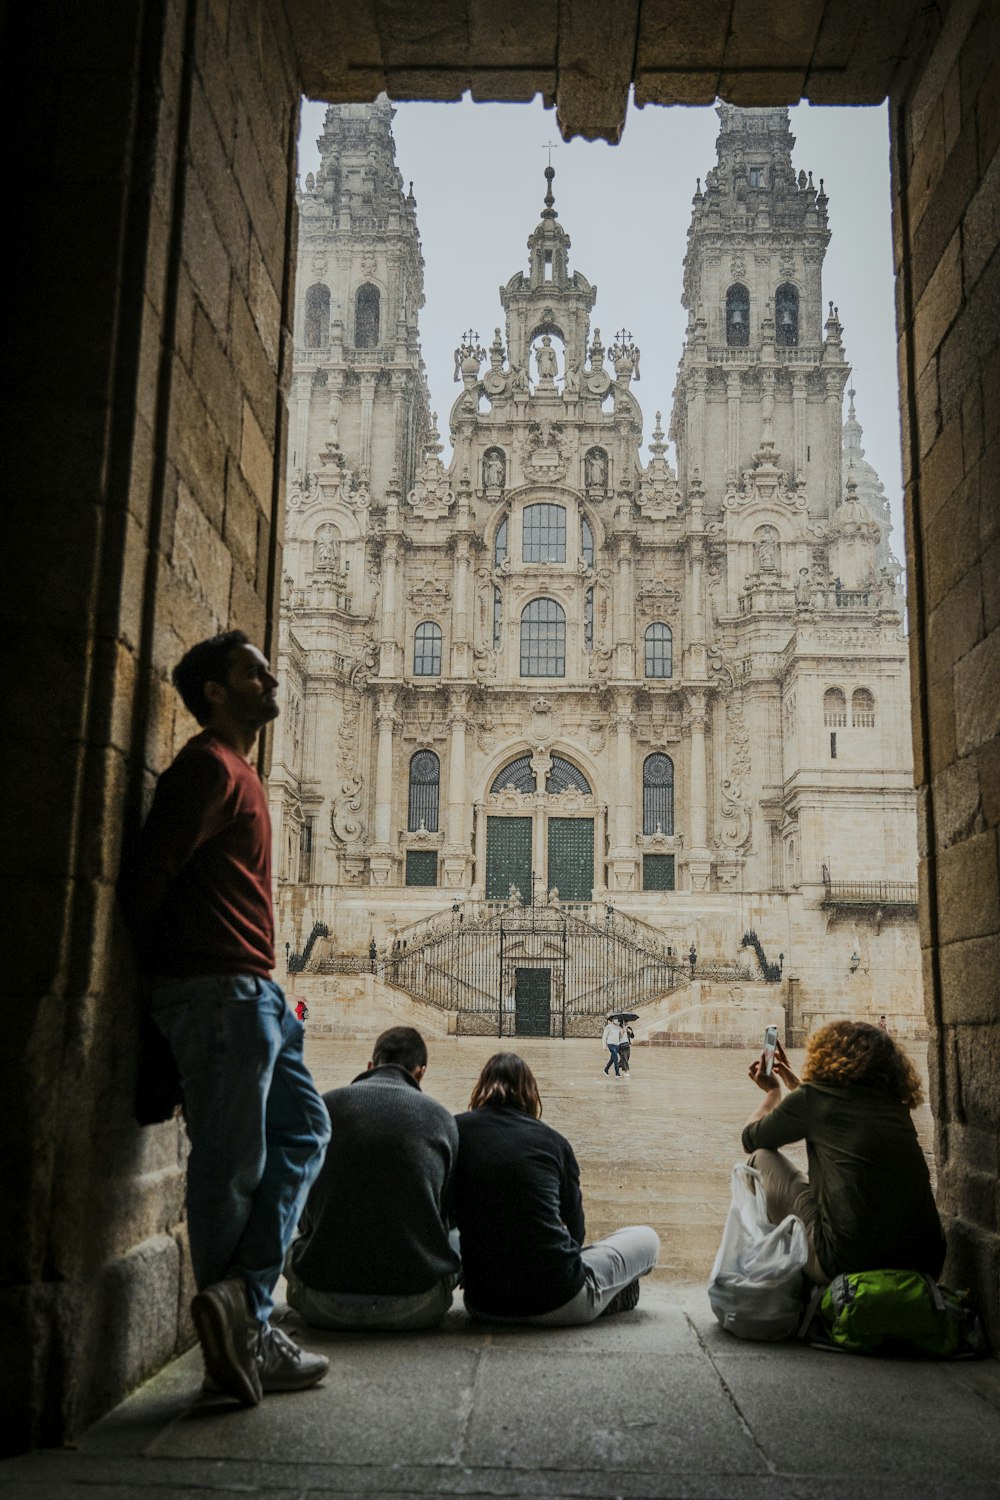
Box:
708;1161;810;1341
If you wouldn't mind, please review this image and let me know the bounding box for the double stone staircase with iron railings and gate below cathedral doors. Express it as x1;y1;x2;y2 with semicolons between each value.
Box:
385;903;687;1037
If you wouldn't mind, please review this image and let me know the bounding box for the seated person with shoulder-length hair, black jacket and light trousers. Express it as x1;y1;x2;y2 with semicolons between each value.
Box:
454;1052;660;1326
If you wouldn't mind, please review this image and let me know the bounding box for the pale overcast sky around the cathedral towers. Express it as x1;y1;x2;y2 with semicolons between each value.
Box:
298;101;903;558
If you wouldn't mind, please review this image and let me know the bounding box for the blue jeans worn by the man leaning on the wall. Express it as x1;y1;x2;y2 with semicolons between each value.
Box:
150;974;330;1323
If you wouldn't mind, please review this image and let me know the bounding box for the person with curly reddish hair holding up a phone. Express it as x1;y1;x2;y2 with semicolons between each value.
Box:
742;1022;945;1283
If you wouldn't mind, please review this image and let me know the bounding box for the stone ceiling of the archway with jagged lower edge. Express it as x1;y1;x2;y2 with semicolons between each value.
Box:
285;0;929;141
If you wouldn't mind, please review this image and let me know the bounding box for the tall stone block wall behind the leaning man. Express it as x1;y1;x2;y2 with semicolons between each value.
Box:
0;0;298;1448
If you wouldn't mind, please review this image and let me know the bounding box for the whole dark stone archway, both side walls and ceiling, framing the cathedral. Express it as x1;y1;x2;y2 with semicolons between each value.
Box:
1;0;1000;1446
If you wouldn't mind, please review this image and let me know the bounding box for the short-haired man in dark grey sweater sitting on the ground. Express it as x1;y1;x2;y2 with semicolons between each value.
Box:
285;1026;460;1329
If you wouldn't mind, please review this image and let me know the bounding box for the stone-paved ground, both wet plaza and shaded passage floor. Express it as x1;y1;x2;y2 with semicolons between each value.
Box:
0;1038;1000;1500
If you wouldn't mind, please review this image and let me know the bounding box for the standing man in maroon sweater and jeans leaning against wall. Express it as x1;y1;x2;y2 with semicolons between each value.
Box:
121;630;330;1406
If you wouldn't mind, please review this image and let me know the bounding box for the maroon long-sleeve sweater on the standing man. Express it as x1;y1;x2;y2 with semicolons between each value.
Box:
121;729;274;978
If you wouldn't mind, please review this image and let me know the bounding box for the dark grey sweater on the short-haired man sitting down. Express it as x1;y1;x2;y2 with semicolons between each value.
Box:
291;1064;459;1296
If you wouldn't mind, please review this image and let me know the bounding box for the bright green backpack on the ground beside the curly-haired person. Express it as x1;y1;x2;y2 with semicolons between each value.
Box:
807;1271;985;1359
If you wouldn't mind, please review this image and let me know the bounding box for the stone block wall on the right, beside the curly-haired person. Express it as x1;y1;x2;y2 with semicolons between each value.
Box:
892;0;1000;1338
